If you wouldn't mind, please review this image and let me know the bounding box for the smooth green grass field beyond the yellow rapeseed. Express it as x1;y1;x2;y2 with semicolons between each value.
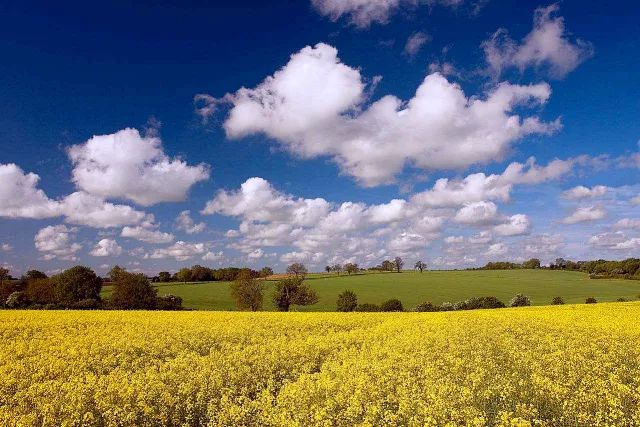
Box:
103;270;640;311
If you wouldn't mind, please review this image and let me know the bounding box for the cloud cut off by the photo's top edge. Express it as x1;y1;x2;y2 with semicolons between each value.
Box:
311;0;464;28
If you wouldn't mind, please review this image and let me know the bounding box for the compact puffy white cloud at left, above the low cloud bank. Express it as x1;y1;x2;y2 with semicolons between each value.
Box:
68;128;209;206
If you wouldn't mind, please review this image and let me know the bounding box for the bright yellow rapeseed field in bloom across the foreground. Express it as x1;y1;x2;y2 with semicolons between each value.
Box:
0;303;640;426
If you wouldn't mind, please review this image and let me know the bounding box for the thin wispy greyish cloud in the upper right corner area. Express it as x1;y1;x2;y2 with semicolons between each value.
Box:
482;3;593;78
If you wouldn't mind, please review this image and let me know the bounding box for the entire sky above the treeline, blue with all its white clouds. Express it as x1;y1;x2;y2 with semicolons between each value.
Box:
0;0;640;273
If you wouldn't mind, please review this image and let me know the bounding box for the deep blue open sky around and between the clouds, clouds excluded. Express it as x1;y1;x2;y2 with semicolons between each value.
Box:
0;0;640;272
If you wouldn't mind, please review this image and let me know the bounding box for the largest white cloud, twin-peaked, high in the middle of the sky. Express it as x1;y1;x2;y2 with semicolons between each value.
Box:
206;43;560;186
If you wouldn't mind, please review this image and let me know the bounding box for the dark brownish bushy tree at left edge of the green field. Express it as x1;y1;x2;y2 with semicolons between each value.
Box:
109;270;158;310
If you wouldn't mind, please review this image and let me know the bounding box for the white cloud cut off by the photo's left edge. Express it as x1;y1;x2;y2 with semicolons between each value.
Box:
0;163;60;218
